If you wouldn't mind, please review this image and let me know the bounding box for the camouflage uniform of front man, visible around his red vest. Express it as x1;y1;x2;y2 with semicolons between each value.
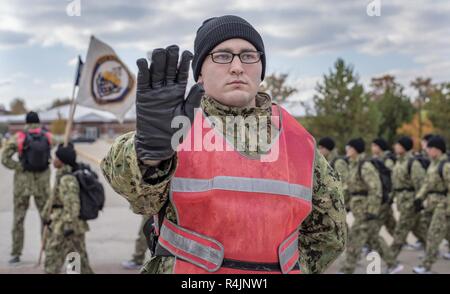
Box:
101;93;347;273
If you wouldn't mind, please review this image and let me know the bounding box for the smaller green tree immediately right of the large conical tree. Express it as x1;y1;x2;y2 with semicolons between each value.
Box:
369;75;414;144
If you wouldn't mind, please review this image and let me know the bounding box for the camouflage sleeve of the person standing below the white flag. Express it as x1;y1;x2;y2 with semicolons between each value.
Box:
59;175;80;225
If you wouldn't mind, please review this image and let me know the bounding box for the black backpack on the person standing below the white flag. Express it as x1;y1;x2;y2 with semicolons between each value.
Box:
73;163;105;220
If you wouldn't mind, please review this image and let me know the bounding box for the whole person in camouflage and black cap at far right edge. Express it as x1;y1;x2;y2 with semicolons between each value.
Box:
413;135;450;274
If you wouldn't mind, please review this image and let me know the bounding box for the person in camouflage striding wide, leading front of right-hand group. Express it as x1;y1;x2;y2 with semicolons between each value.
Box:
340;138;401;274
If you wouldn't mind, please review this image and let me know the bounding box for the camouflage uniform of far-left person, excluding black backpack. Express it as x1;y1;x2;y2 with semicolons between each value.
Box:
2;123;50;261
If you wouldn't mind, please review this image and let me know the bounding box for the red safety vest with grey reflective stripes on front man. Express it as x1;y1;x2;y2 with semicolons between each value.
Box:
158;106;315;274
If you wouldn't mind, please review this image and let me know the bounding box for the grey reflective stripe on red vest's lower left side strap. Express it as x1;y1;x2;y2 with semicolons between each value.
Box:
160;220;224;271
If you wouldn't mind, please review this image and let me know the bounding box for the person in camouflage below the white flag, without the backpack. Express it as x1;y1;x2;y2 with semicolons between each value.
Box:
44;144;93;274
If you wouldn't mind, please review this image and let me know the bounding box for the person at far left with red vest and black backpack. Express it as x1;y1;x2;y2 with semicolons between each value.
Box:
2;111;52;264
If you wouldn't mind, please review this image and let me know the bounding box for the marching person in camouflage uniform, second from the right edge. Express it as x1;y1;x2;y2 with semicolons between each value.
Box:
391;138;426;258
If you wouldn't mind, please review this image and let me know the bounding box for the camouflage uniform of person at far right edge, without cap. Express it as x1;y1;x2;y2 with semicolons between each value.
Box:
414;149;450;272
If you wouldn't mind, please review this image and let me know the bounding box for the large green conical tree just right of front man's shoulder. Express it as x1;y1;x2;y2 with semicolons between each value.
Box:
307;58;380;151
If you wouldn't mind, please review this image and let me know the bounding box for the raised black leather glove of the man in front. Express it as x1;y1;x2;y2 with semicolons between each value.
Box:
135;45;204;160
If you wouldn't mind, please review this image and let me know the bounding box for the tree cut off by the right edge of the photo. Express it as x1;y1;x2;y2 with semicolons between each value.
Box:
424;82;450;140
